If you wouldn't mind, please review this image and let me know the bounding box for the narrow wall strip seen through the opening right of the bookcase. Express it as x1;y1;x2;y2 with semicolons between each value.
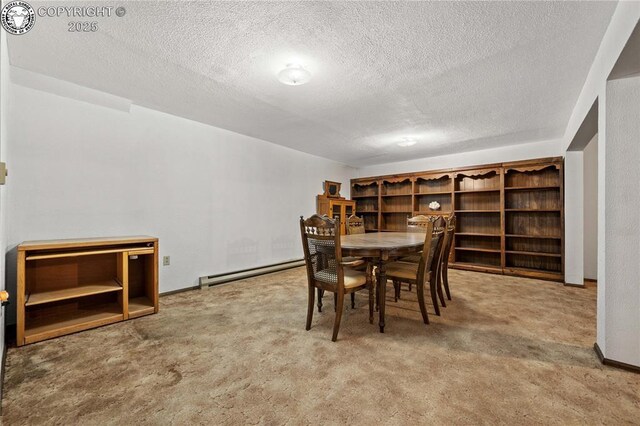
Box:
583;134;598;280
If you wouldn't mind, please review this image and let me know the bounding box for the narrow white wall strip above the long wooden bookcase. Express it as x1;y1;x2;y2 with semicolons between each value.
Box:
358;140;563;177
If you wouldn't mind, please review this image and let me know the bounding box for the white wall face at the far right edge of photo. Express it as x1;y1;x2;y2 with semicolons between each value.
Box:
604;77;640;366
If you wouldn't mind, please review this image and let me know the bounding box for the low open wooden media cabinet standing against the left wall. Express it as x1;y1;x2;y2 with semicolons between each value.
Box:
16;236;158;346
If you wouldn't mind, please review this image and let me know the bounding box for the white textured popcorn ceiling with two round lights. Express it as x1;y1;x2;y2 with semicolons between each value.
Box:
8;1;616;166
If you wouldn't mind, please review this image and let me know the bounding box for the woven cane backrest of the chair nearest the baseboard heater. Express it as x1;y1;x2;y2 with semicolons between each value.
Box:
300;215;344;286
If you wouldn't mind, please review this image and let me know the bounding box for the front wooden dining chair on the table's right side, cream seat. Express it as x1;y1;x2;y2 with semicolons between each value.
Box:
387;221;445;324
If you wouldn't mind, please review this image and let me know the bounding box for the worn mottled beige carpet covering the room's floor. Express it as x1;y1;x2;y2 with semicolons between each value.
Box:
2;268;640;425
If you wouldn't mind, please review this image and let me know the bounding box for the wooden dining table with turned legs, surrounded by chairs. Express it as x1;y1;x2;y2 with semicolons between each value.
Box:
340;232;425;333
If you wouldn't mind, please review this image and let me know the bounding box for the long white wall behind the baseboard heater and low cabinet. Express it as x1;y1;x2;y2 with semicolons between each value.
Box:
3;75;355;322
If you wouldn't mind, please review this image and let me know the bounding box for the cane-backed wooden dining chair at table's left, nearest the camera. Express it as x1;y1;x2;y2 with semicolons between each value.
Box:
300;215;373;342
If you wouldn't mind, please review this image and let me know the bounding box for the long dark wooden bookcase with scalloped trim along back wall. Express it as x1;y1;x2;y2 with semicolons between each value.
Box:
351;157;564;281
